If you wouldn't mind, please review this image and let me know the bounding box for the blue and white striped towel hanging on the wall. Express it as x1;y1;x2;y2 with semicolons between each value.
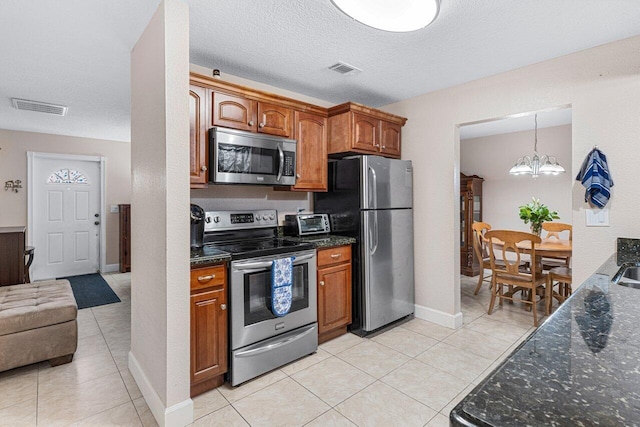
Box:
576;148;613;209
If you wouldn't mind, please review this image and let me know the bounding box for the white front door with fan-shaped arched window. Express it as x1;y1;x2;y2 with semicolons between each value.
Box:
29;156;102;280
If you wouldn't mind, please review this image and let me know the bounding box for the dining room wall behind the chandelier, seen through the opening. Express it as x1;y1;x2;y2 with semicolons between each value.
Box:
460;125;575;237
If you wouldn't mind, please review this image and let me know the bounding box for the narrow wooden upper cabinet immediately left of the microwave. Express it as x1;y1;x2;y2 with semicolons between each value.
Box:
189;86;209;188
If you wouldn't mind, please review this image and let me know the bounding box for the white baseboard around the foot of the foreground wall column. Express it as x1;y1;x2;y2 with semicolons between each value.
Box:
129;352;193;427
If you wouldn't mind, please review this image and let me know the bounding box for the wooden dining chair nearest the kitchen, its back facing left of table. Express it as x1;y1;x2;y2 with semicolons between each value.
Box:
484;230;547;327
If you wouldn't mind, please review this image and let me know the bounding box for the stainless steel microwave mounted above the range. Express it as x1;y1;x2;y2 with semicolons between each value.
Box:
209;127;297;185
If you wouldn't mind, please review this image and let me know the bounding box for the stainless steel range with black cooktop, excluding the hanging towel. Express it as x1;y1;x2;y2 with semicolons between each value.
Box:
204;210;318;386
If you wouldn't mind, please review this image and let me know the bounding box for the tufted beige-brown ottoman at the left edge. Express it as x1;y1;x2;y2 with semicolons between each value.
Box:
0;280;78;372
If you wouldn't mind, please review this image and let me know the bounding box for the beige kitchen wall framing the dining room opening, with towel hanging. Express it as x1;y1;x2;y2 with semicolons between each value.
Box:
386;37;640;324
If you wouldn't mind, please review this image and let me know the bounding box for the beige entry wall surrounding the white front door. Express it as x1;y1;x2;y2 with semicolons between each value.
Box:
0;129;131;264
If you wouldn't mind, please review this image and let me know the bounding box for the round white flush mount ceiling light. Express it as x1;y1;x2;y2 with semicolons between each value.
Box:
331;0;440;32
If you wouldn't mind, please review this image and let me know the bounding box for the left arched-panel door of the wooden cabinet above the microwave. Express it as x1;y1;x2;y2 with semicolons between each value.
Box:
211;92;258;132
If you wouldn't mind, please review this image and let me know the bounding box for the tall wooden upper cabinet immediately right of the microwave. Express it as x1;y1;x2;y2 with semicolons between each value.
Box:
293;111;327;191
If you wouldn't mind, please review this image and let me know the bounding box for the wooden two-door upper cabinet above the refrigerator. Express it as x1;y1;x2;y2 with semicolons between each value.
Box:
328;102;407;158
